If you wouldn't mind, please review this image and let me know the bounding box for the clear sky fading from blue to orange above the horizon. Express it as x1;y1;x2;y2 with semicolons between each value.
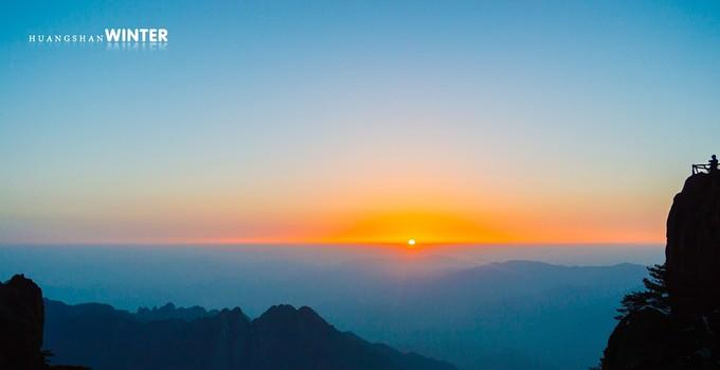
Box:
0;0;720;244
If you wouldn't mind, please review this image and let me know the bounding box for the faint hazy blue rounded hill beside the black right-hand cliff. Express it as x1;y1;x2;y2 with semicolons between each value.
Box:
348;261;646;370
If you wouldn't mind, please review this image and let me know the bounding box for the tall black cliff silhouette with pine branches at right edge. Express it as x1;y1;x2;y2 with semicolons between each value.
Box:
600;171;720;370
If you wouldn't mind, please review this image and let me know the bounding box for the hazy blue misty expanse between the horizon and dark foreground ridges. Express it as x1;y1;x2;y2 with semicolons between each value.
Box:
0;246;662;370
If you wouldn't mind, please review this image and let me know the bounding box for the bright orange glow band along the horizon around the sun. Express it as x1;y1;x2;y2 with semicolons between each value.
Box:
8;210;665;249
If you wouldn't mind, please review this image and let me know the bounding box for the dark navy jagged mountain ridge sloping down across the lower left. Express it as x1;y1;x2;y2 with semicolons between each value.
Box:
45;300;454;370
